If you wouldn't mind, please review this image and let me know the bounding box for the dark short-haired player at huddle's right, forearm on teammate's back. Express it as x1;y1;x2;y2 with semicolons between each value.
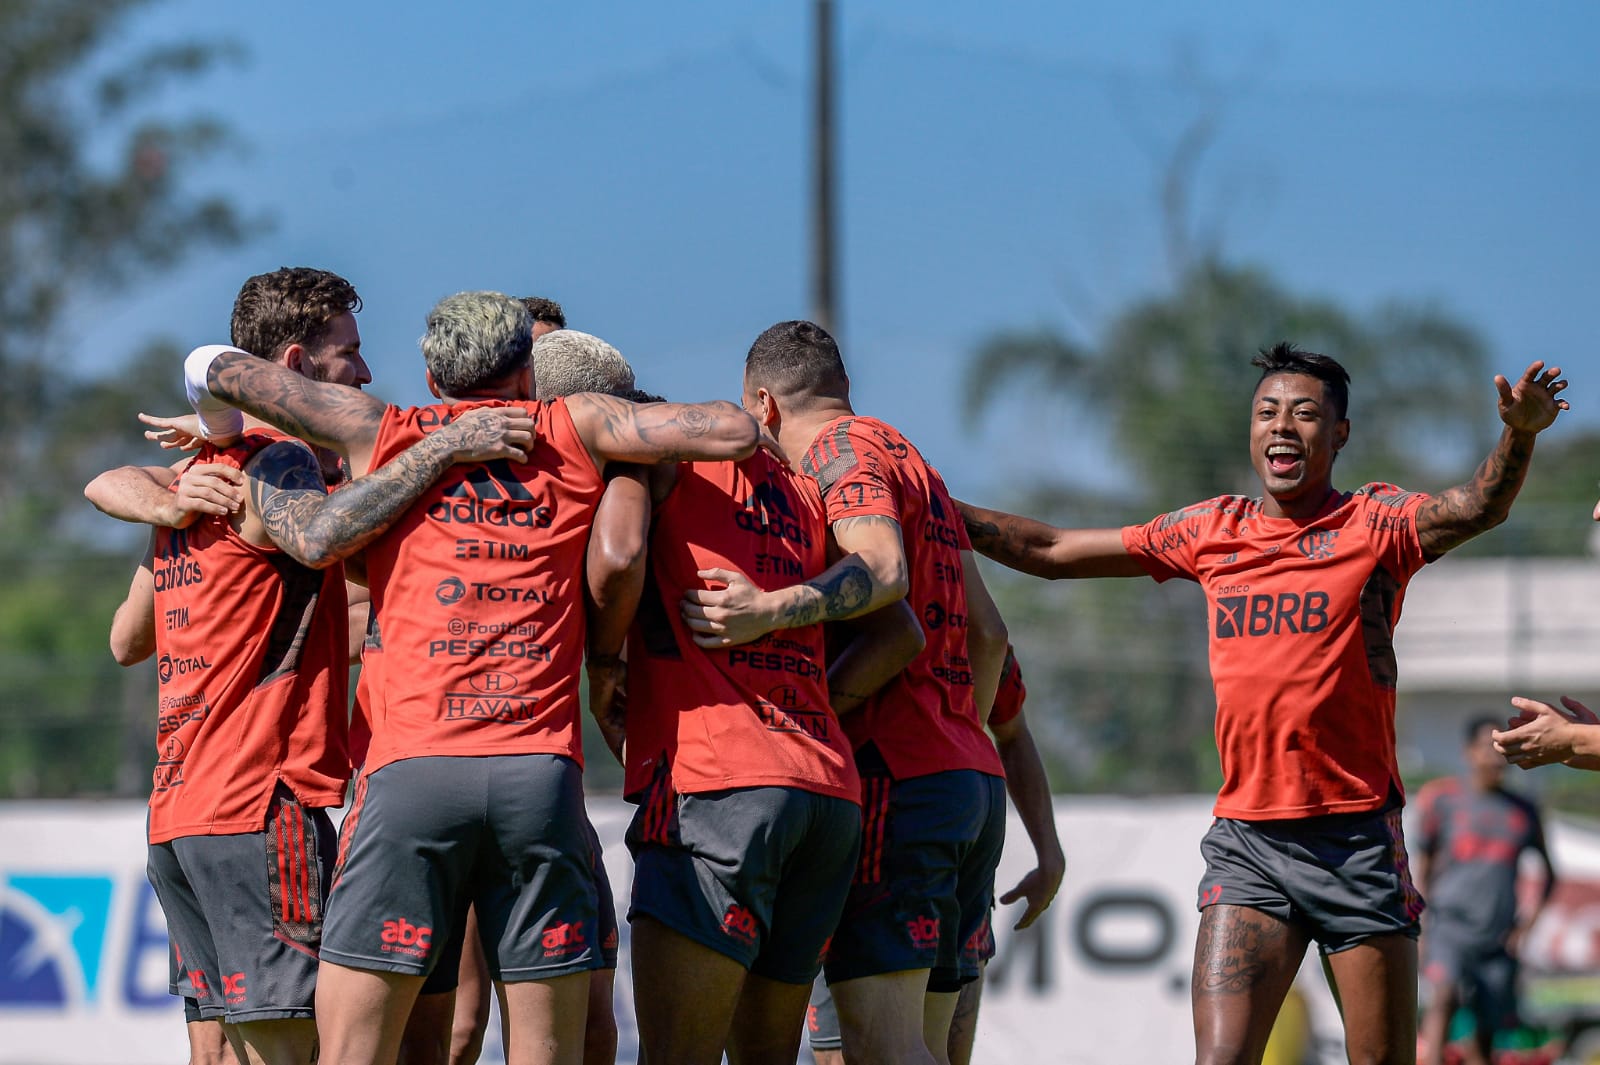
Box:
691;321;1006;1062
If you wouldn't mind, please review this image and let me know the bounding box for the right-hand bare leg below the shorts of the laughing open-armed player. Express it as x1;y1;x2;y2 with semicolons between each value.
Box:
1326;934;1416;1065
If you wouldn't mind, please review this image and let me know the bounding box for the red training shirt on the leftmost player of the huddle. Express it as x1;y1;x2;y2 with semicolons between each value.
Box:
149;430;350;843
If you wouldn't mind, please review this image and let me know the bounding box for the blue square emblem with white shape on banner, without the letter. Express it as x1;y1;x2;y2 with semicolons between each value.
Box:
0;875;114;1006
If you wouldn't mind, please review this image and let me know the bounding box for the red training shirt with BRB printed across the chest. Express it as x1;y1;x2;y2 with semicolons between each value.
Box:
1122;485;1427;820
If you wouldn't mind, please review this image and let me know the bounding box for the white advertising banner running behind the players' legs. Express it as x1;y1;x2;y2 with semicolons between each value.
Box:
0;796;1600;1065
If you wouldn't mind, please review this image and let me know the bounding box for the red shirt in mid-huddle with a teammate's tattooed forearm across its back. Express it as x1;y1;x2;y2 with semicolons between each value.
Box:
624;451;861;803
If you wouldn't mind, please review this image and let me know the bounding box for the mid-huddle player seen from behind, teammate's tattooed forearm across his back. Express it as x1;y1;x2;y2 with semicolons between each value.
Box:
624;355;922;1065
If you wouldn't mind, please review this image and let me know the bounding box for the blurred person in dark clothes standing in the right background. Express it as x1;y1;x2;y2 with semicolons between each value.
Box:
1413;716;1555;1065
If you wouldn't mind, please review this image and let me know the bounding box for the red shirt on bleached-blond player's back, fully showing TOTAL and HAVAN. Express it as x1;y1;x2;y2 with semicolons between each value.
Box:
362;400;605;772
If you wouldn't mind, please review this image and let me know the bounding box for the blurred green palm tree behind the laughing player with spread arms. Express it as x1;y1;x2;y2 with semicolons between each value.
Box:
966;254;1494;792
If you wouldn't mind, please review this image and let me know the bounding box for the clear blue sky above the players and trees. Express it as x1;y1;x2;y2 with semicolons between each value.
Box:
72;0;1600;502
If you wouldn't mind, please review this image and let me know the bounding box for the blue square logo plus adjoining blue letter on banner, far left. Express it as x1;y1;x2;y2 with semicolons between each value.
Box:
0;870;178;1014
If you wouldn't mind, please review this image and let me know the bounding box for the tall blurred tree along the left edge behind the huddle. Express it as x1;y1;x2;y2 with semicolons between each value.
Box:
0;0;251;796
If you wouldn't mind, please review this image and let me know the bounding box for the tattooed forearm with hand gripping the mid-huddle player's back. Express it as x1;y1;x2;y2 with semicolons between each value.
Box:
680;515;910;648
